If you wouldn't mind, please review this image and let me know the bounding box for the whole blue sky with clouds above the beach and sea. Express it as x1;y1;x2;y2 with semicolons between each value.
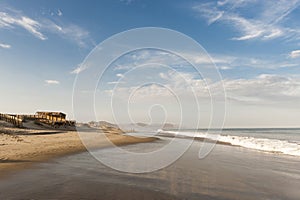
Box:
0;0;300;128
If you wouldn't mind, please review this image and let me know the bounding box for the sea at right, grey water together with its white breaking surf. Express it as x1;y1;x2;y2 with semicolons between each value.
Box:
158;128;300;157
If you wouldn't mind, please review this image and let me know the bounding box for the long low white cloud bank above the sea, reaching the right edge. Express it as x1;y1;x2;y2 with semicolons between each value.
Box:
104;71;300;104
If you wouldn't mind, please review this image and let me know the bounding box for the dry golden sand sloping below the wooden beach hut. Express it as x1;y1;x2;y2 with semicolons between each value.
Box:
0;124;156;176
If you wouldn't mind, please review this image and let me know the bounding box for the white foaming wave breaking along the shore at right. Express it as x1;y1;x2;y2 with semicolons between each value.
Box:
158;130;300;156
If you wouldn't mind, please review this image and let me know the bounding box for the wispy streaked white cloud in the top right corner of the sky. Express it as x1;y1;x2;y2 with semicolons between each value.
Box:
193;0;300;40
